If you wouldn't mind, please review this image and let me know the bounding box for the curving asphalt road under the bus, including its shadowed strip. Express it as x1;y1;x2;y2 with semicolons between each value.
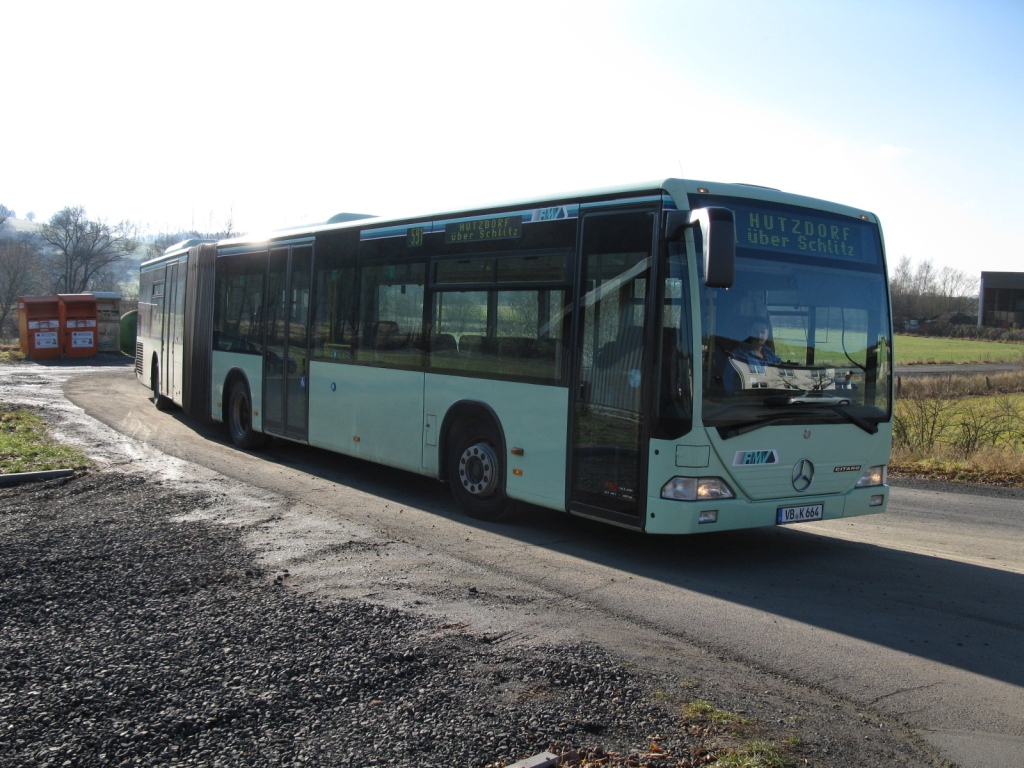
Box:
65;370;1024;768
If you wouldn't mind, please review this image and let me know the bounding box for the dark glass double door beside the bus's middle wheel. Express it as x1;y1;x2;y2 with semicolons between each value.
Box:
263;246;312;440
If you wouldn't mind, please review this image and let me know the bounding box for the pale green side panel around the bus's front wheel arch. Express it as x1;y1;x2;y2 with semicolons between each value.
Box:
423;375;568;510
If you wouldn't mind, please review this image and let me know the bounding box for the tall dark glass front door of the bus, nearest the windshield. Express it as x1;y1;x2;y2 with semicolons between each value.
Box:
568;210;655;527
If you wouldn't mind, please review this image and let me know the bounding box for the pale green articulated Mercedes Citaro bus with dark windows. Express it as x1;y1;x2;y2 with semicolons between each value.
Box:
135;179;893;534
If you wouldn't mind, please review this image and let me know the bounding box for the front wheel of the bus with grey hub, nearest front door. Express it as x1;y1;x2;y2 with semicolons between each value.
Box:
447;419;515;522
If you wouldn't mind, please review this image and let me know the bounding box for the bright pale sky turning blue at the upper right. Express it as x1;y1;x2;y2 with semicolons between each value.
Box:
0;0;1024;272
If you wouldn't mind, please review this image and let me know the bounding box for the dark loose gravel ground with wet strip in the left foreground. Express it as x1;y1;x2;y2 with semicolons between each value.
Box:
0;371;939;768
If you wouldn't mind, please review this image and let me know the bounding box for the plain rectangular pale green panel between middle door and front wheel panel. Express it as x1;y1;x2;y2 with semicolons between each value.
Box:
309;361;424;474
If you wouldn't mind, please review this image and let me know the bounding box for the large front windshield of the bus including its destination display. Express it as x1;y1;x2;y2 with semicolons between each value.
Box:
699;197;892;438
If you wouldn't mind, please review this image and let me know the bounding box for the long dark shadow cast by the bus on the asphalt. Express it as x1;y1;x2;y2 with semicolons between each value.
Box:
77;376;1024;686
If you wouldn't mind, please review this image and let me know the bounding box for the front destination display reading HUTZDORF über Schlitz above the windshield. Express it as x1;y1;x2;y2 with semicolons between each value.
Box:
700;199;881;264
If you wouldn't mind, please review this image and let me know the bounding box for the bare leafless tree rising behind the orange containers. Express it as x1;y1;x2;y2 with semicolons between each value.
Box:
39;206;137;293
